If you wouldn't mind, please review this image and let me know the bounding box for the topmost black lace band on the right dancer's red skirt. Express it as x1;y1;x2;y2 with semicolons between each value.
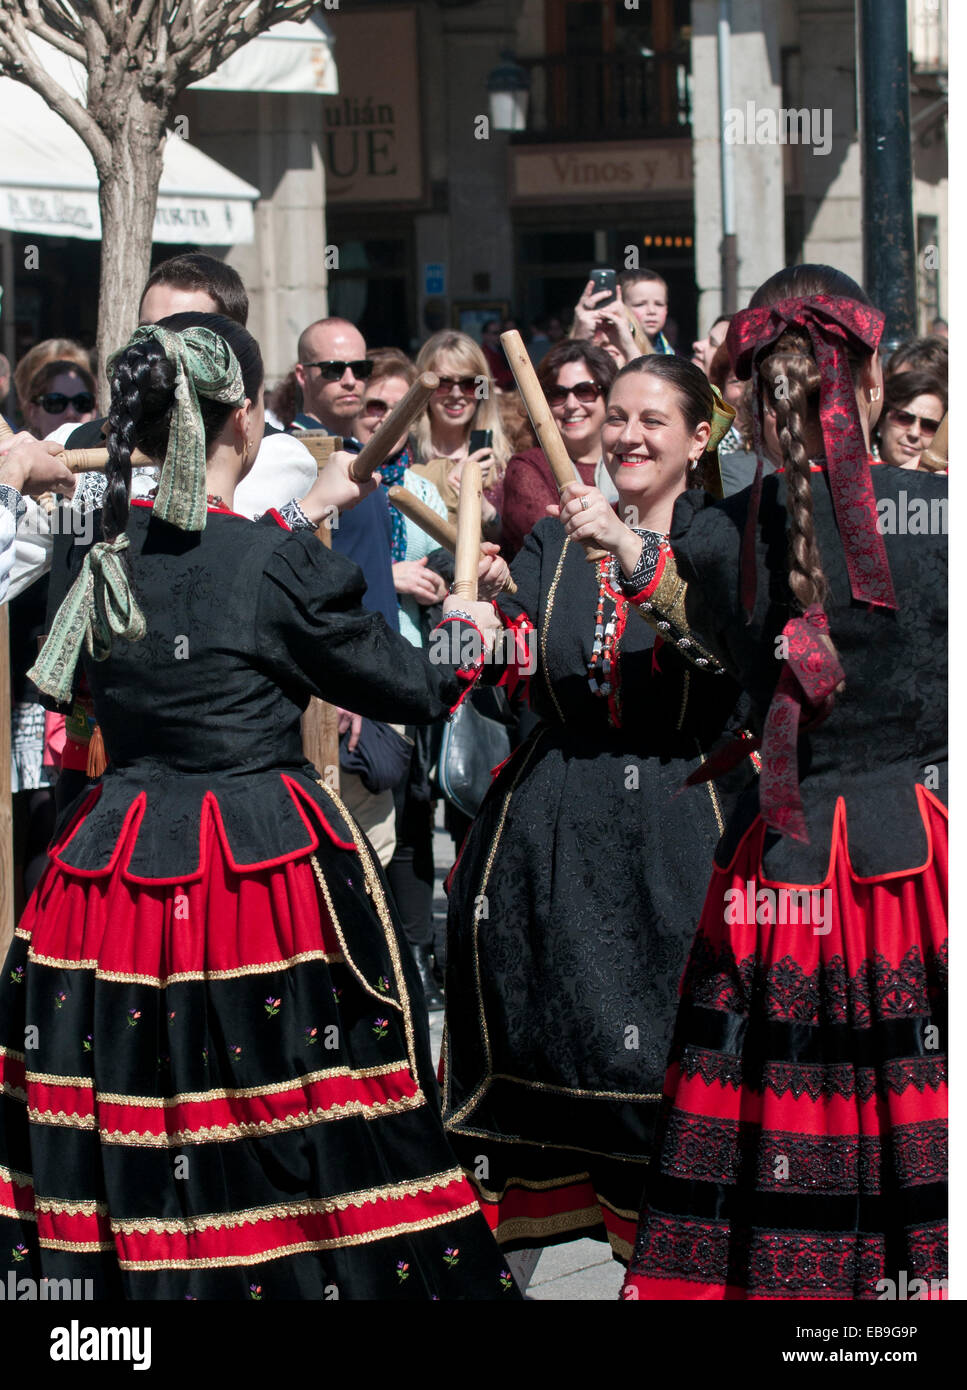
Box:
682;934;948;1027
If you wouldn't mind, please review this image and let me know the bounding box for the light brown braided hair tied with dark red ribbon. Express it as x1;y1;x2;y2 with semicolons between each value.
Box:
749;265;870;612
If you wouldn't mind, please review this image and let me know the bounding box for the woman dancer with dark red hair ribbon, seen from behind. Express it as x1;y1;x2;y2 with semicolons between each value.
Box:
563;265;948;1300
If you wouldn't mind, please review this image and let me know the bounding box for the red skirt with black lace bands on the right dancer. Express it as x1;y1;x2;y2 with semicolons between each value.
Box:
624;788;948;1300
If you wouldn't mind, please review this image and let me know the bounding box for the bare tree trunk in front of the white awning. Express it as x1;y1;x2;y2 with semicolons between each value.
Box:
92;82;165;411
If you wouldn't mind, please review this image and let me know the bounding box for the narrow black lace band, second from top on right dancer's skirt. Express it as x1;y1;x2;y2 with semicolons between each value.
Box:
678;1047;948;1101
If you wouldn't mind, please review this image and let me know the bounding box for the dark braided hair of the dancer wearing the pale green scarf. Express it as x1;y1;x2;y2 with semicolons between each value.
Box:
101;313;264;541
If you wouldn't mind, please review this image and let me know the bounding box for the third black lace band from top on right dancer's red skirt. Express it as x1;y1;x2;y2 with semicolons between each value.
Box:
661;1111;948;1197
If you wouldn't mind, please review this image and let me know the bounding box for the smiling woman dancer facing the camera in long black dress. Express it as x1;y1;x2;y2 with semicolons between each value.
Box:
443;356;753;1262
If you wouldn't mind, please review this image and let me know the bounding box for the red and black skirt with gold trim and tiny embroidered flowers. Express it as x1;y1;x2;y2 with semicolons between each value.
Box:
0;795;518;1301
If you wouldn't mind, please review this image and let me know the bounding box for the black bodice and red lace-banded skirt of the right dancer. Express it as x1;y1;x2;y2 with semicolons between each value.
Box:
625;464;948;1300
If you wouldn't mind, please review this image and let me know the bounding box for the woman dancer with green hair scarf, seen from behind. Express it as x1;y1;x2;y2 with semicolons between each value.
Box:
0;314;517;1300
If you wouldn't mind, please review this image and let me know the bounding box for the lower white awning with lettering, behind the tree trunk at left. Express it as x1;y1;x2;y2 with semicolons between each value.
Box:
0;26;272;246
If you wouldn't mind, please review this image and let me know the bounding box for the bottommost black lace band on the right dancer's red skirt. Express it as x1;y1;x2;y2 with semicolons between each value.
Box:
631;1212;946;1300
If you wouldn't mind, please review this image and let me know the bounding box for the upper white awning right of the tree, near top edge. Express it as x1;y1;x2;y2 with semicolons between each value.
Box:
192;14;339;96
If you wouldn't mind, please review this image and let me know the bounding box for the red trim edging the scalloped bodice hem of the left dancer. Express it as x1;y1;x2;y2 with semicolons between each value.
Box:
49;773;356;884
